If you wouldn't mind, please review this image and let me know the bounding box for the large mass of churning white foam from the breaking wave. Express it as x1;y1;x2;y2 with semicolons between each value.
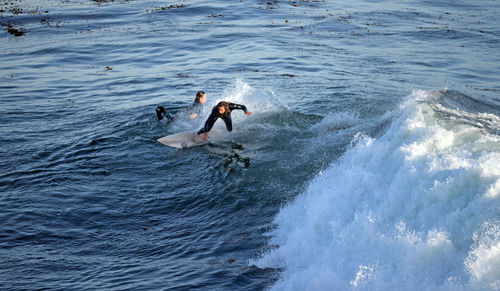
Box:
252;91;500;290
